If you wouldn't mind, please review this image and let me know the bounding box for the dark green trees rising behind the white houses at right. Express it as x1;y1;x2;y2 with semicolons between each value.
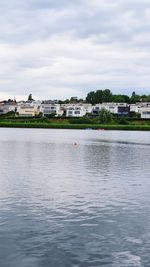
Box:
86;89;150;105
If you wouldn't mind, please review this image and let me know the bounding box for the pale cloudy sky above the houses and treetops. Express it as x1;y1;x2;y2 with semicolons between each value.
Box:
0;0;150;100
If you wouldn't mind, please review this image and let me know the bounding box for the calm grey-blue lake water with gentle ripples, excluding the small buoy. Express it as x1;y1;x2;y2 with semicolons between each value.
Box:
0;129;150;267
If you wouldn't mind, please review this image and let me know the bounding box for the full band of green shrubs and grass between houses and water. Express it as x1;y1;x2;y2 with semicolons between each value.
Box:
0;112;150;131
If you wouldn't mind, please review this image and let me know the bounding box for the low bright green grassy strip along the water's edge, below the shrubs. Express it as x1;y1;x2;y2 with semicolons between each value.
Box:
0;119;150;131
